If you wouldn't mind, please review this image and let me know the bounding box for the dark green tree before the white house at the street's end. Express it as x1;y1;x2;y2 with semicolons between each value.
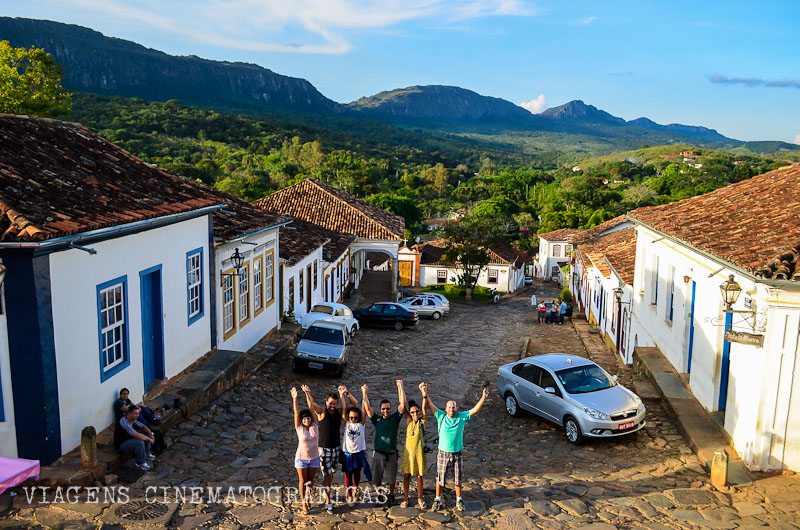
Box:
441;217;502;300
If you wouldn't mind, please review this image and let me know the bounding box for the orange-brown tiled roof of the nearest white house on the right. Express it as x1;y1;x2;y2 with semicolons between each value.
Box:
628;164;800;280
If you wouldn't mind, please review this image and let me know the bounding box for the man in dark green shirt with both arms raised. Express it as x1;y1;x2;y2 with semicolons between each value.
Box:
361;379;406;506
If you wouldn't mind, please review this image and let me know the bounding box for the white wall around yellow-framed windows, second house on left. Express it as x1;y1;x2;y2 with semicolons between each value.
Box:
214;228;282;351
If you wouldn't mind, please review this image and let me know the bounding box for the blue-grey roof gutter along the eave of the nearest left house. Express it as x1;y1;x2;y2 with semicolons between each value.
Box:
0;204;225;252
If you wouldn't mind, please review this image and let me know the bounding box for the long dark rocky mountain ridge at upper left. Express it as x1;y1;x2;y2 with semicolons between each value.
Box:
0;17;346;114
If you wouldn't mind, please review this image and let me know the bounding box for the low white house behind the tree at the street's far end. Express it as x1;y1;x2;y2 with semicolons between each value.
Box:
412;239;528;293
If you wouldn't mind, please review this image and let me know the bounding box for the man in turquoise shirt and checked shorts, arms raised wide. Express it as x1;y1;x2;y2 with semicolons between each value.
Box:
422;384;489;512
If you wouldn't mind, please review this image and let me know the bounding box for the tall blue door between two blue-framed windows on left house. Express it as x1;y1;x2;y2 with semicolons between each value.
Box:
139;265;164;391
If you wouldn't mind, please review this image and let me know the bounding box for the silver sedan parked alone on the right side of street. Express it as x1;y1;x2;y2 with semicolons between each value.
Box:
497;353;646;444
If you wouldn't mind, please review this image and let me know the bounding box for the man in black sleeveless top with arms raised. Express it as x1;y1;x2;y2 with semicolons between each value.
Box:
300;385;358;513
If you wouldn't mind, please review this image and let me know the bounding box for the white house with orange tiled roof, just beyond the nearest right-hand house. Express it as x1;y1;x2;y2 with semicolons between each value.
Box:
571;217;636;364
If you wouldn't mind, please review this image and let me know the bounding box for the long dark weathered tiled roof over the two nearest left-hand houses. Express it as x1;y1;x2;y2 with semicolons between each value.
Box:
0;115;282;241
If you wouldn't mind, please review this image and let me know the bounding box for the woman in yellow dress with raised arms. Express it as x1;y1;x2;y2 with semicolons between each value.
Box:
400;383;428;510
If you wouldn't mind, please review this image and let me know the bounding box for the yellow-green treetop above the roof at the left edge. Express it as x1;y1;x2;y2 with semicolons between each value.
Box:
0;41;71;116
